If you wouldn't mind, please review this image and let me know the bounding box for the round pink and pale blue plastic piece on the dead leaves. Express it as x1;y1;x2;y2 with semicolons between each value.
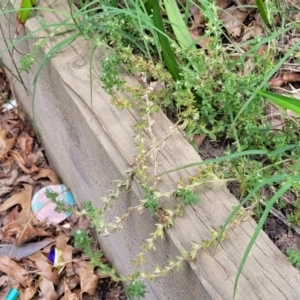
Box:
31;184;75;224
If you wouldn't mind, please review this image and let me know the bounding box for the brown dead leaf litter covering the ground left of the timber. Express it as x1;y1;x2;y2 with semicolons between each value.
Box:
0;68;127;300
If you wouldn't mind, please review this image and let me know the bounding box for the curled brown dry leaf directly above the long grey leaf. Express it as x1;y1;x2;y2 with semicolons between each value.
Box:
2;222;51;246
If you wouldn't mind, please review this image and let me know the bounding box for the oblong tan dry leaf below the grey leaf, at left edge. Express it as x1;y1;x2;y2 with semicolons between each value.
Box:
0;255;32;287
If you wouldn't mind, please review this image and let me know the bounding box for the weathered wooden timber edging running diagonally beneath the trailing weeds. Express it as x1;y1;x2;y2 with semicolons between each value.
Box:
0;0;300;300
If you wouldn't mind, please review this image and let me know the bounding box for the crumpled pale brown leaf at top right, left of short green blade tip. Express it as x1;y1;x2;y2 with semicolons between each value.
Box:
219;6;249;37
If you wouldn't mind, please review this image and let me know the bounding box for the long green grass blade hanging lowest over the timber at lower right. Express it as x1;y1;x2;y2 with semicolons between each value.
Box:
233;181;292;298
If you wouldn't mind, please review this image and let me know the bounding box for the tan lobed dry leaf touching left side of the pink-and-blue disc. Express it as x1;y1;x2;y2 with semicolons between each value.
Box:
0;185;32;222
